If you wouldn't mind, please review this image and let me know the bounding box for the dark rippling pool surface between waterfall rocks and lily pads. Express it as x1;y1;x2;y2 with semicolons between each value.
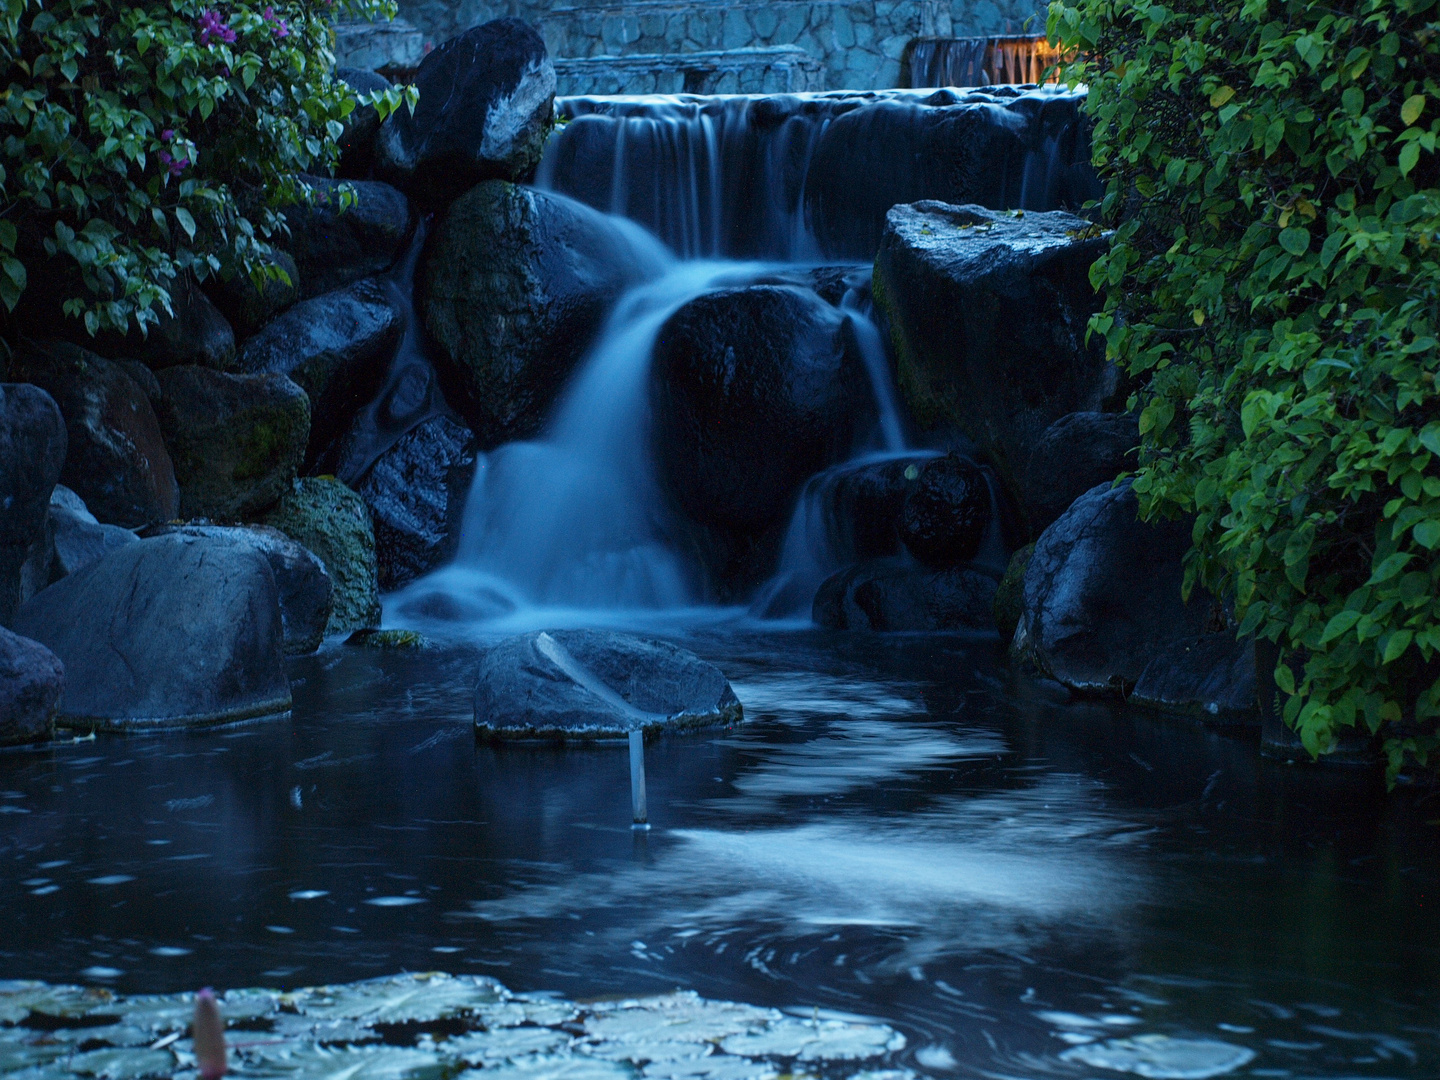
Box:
0;626;1440;1079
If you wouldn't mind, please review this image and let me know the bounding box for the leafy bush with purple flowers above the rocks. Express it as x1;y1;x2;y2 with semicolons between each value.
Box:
0;0;415;334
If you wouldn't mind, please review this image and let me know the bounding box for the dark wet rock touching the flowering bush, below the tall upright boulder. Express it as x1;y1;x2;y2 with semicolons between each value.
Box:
285;176;415;300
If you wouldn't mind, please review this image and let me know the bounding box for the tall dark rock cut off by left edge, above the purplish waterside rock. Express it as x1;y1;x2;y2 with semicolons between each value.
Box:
0;383;66;626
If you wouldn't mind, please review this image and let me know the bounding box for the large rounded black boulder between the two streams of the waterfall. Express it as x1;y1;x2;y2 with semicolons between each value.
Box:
651;285;874;534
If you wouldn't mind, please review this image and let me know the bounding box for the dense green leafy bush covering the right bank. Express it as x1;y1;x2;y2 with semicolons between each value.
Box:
1050;0;1440;775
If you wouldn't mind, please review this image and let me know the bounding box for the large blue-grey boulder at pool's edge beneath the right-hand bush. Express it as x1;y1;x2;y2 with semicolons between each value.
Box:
1012;482;1211;697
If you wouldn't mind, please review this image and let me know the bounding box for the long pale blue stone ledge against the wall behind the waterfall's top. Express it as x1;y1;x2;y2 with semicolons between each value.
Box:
554;45;825;96
